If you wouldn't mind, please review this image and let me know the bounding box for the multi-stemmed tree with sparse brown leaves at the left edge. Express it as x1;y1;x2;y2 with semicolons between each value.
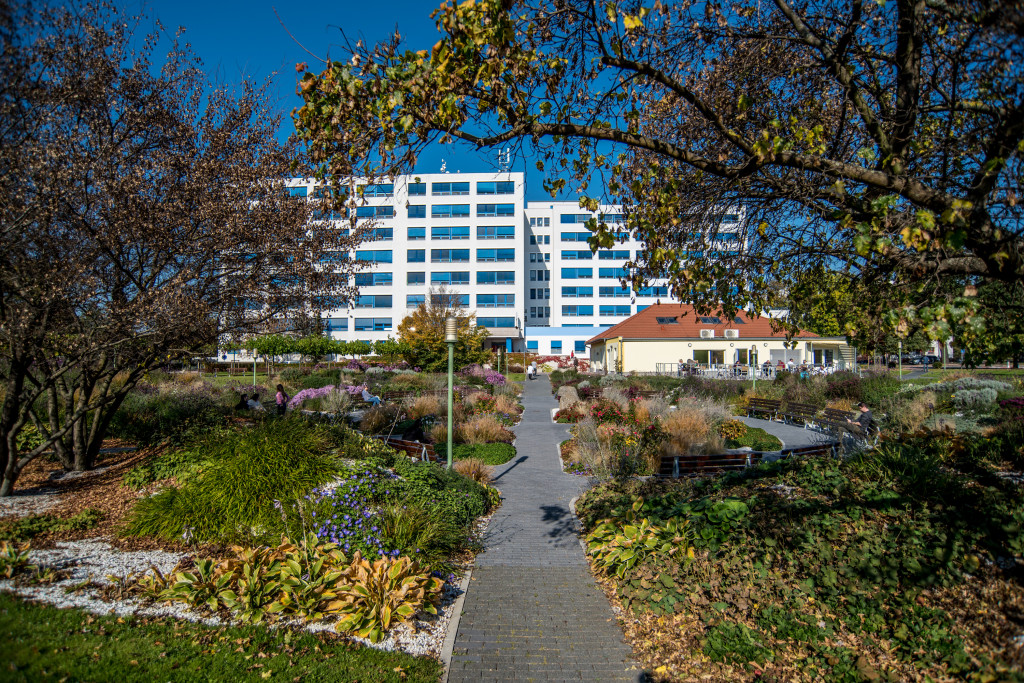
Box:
0;3;358;496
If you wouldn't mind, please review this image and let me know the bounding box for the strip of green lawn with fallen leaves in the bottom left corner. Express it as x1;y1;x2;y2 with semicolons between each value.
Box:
0;594;441;683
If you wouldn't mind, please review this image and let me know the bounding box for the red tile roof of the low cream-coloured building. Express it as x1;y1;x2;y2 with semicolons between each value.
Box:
587;303;818;344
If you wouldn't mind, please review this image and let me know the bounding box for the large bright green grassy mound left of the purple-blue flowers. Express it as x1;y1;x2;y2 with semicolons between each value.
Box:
125;419;339;543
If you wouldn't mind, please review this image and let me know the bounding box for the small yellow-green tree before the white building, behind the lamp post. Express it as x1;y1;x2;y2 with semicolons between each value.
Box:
398;289;490;373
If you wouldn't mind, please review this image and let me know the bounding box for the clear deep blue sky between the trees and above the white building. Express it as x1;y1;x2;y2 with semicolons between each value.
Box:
105;0;550;200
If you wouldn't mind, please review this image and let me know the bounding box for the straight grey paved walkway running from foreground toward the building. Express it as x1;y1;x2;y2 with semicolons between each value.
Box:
449;375;643;681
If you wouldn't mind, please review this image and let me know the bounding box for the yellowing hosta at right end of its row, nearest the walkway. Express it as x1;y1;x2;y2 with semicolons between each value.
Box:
332;552;443;643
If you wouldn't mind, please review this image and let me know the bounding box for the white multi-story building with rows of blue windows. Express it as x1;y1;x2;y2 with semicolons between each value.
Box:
280;172;743;355
